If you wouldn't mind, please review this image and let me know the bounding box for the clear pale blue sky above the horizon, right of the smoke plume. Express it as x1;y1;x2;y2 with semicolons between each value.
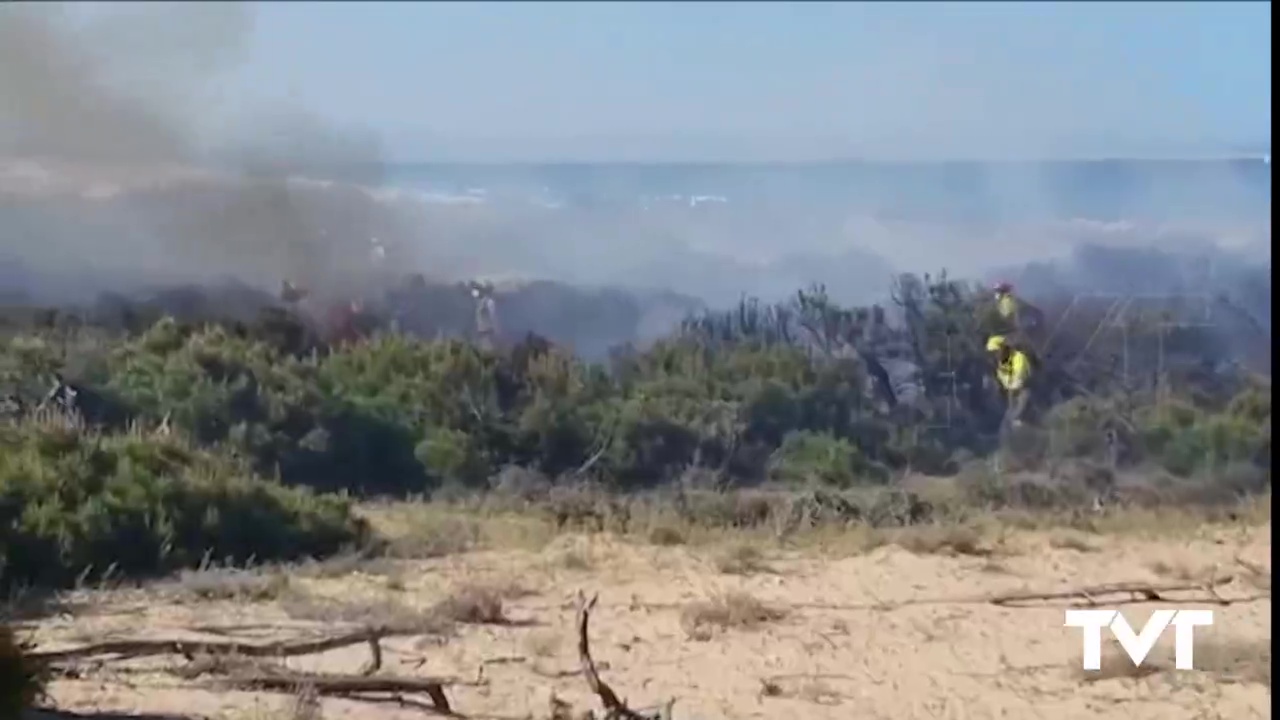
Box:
12;1;1271;161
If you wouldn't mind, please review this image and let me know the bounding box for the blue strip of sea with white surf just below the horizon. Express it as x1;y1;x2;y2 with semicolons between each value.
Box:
376;155;1271;222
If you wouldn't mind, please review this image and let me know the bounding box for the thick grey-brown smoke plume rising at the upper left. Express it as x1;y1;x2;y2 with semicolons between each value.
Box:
0;3;398;302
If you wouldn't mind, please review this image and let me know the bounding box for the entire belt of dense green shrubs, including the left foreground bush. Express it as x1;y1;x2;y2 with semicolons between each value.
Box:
0;271;1271;584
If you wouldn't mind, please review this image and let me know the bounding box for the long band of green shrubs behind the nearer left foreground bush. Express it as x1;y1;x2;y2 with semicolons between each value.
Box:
0;270;1271;515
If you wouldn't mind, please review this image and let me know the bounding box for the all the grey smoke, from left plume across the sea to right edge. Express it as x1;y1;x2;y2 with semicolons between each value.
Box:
0;3;1270;356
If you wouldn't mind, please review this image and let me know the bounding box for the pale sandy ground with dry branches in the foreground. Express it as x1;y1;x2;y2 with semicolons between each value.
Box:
27;525;1271;720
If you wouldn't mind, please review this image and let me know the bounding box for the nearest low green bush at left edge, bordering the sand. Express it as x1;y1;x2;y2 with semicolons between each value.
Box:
0;421;365;585
